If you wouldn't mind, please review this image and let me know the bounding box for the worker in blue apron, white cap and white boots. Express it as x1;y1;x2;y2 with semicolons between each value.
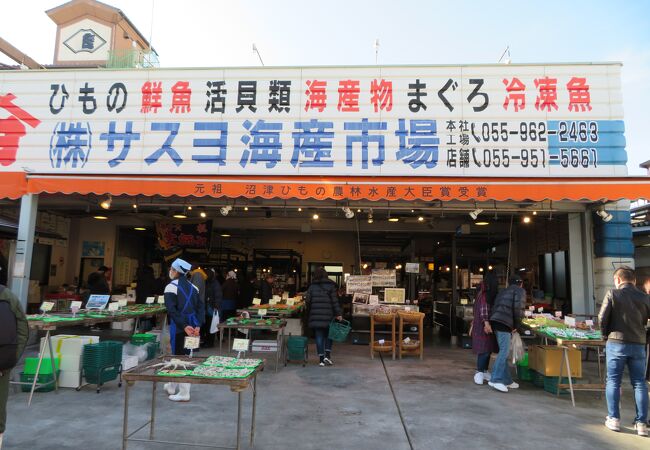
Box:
165;258;205;402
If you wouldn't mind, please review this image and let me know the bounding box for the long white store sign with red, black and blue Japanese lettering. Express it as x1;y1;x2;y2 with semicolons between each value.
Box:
0;64;627;177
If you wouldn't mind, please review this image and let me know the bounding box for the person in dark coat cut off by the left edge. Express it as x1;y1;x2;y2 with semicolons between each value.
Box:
0;285;29;448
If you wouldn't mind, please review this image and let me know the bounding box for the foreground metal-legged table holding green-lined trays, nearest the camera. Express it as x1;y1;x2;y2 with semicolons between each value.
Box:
122;356;264;450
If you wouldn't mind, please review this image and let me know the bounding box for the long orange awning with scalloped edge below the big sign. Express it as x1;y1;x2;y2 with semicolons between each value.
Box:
6;173;650;201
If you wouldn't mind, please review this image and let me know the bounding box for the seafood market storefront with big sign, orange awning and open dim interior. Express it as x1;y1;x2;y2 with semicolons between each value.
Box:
0;64;650;340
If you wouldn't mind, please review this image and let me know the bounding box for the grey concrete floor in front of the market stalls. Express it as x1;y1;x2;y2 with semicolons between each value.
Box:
4;336;650;450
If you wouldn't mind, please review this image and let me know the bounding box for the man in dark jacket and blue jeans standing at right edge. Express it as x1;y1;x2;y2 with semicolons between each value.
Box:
598;266;650;436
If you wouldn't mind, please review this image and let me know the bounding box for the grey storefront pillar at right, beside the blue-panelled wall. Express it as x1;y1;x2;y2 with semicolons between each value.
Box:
569;212;597;314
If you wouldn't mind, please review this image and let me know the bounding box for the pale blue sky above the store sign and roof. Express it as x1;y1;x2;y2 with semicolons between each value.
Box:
0;0;650;174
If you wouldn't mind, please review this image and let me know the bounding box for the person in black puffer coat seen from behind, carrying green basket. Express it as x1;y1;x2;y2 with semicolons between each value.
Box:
305;267;343;367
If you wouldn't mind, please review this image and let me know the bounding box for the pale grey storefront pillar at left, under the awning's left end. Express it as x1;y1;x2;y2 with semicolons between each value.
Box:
10;194;38;310
